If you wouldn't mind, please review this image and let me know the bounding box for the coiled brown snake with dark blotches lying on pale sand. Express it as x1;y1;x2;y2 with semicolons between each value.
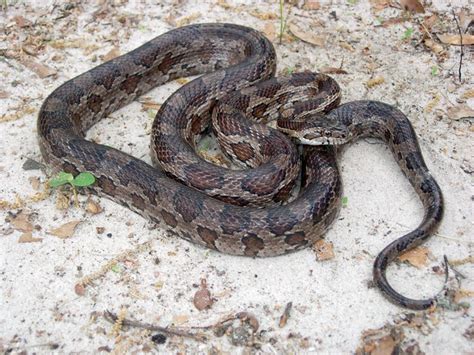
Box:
37;23;444;309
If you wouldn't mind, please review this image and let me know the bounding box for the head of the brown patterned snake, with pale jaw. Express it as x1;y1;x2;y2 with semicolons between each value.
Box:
277;113;350;145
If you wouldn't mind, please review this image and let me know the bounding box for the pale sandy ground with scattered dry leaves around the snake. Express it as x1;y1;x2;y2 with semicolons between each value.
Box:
0;0;474;354
